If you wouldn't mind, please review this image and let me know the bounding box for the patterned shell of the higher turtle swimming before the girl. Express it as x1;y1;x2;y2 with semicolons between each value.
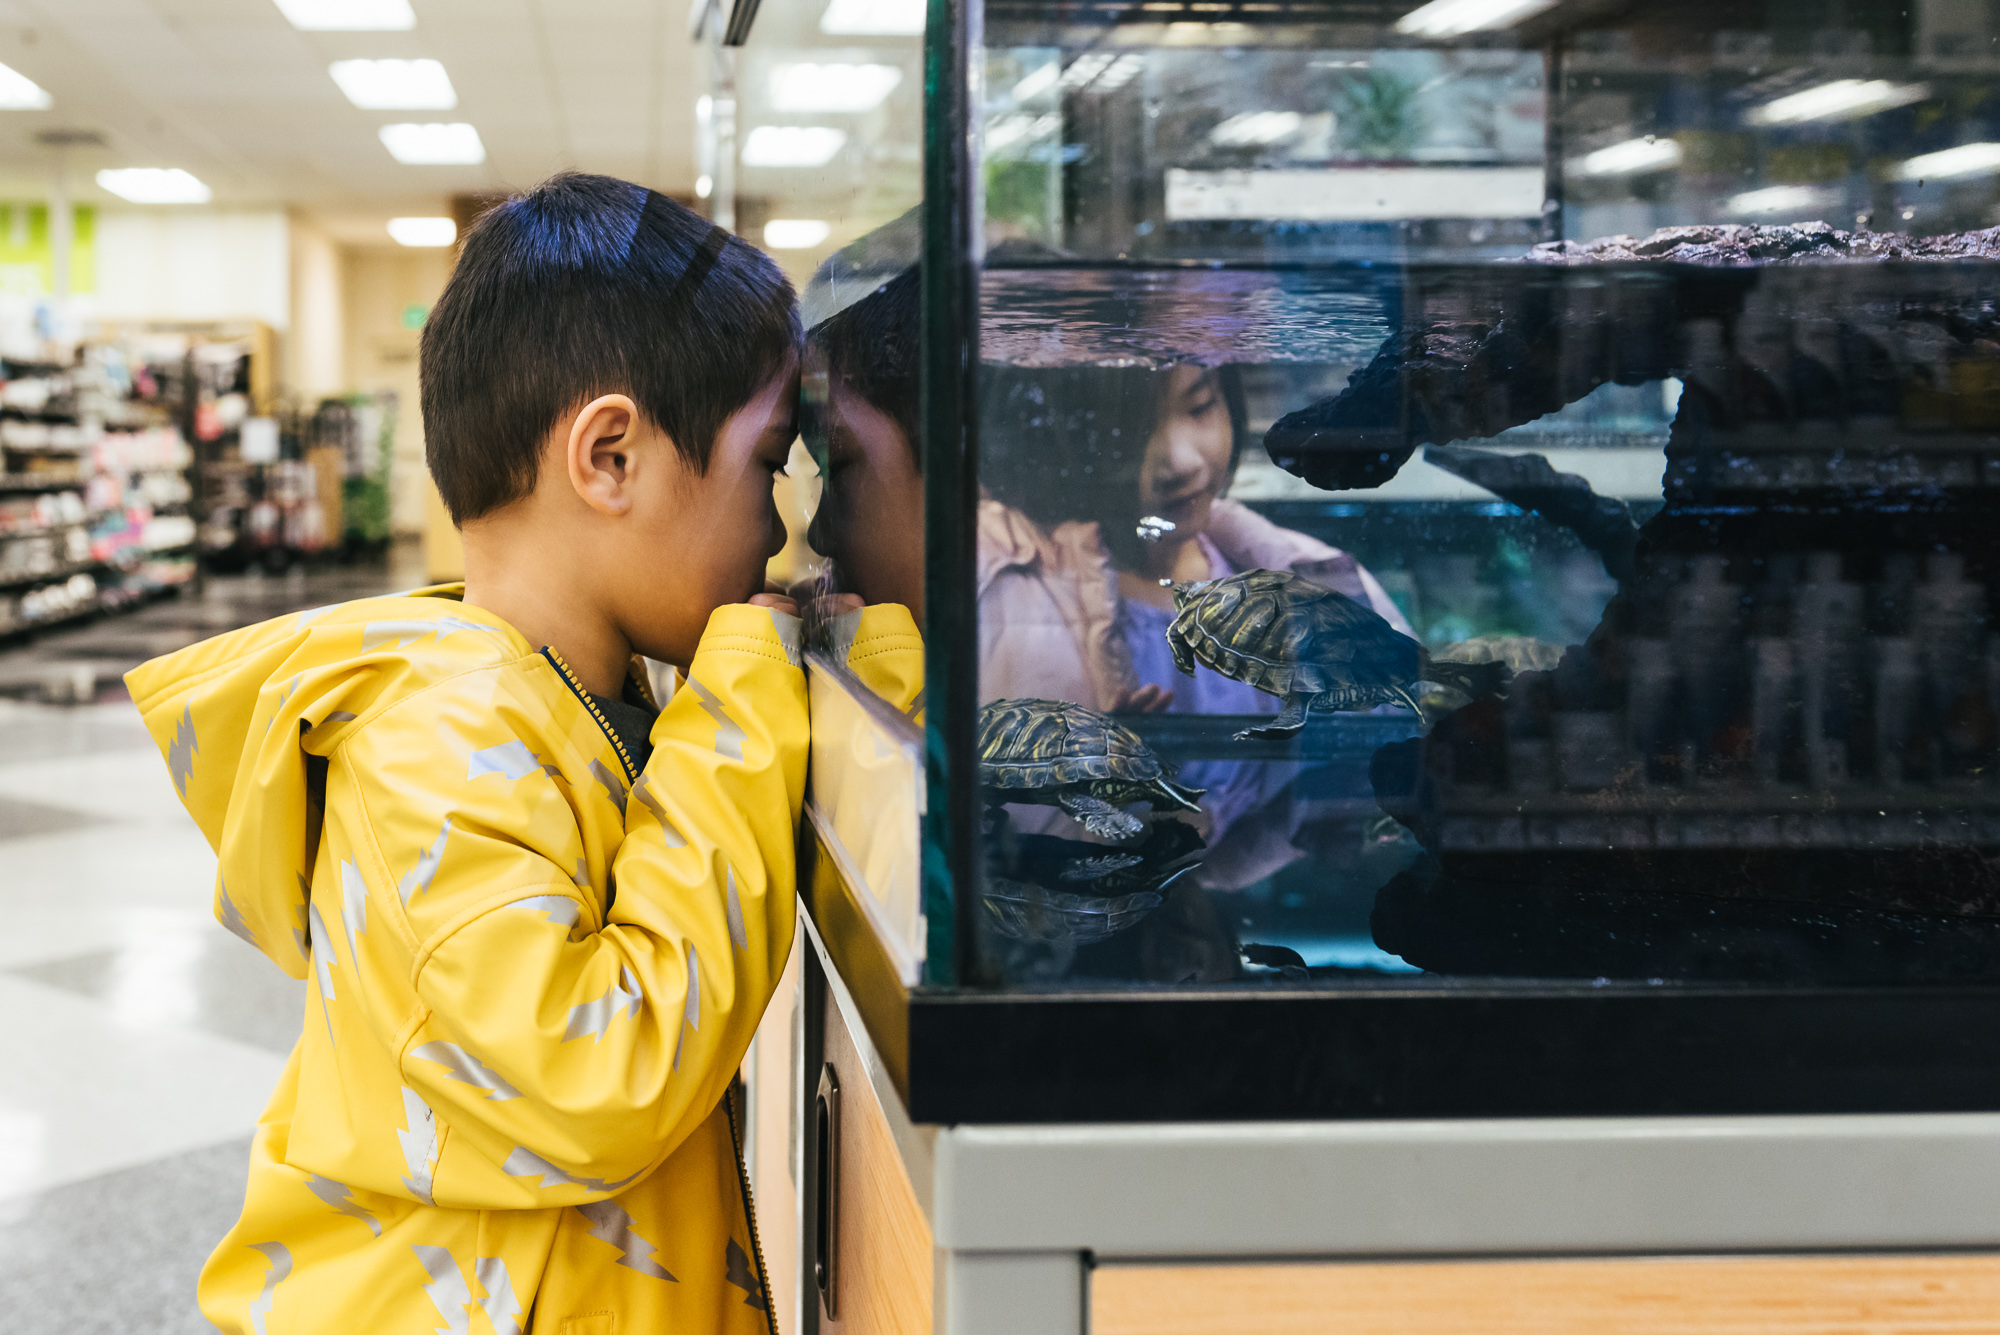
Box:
1166;570;1418;695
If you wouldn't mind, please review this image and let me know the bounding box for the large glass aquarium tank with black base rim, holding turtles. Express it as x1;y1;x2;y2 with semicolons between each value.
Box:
720;0;2000;1119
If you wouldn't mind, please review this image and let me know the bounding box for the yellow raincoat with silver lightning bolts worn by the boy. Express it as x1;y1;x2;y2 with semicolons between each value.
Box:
128;586;880;1335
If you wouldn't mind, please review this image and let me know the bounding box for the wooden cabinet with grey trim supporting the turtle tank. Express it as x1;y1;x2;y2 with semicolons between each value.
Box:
768;887;2000;1335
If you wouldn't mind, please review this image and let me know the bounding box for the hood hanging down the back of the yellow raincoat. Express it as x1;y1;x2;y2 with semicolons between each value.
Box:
126;584;534;977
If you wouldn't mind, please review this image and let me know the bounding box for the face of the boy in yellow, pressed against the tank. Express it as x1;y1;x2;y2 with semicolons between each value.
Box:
606;364;798;666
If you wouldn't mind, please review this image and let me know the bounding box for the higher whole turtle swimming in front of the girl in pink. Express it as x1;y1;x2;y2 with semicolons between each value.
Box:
1166;570;1508;741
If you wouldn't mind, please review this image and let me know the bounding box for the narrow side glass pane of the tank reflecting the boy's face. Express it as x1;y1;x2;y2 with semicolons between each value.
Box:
724;0;928;971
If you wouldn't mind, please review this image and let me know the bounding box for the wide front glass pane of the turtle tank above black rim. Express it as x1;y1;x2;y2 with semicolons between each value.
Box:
964;0;2000;985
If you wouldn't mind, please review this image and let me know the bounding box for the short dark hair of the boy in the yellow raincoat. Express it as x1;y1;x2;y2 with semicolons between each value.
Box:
420;172;798;524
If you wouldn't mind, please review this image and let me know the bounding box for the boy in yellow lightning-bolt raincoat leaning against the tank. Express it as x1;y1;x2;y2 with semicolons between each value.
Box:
128;176;828;1335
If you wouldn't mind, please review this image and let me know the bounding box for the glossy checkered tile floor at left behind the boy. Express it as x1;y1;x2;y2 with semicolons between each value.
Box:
0;572;416;1335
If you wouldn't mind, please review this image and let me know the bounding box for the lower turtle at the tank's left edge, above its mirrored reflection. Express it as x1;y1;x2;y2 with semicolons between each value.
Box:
978;699;1202;839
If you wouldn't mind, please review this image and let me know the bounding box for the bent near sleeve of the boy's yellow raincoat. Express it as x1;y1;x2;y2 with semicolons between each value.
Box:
348;606;806;1207
